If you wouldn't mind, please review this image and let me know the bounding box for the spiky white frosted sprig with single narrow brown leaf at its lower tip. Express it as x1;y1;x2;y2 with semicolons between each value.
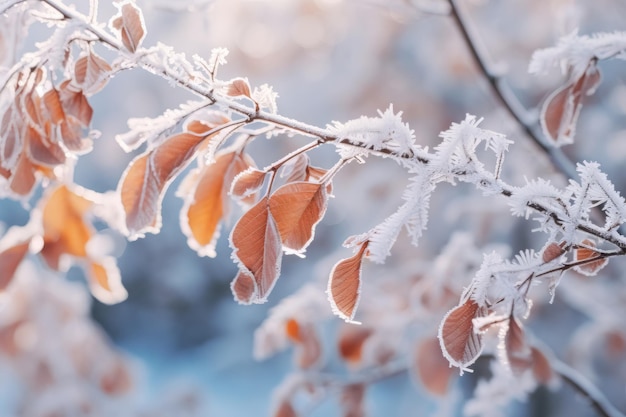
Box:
328;115;511;321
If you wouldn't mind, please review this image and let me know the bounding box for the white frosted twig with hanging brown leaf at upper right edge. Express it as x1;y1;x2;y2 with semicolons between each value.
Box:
529;32;626;146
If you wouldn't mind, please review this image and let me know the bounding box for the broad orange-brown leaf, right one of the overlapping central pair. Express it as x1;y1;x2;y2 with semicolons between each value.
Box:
269;182;328;252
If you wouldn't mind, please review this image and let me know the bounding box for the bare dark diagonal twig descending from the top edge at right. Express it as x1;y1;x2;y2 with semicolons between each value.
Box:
449;0;577;178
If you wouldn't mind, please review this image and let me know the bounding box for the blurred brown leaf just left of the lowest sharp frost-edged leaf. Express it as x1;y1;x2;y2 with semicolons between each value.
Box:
411;338;454;396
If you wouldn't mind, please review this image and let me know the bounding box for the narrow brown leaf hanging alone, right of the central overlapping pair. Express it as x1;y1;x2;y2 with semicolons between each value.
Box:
327;241;369;322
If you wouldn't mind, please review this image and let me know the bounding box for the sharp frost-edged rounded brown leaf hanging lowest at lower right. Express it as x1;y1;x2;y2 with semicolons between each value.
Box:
438;298;484;372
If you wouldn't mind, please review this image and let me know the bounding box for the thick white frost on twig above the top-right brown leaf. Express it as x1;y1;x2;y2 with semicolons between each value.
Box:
528;30;626;79
